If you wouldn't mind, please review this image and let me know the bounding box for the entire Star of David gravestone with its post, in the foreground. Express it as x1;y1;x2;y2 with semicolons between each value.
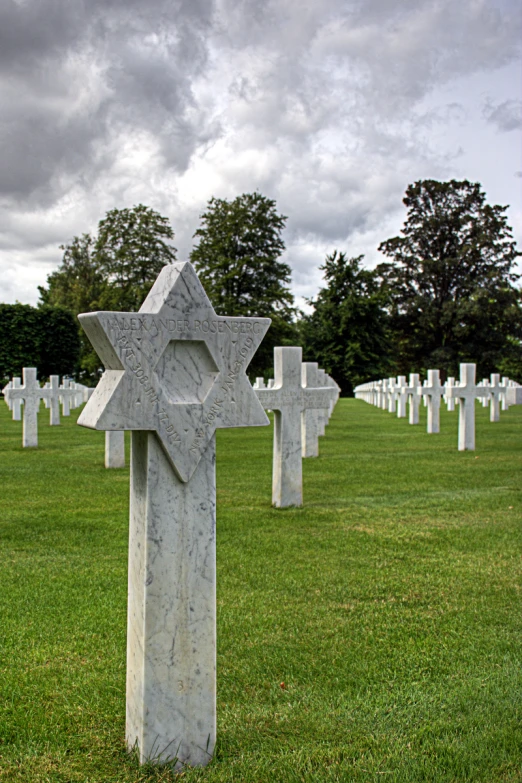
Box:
78;263;270;766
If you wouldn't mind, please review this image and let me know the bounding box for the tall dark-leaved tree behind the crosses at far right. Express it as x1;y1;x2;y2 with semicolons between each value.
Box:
377;179;522;377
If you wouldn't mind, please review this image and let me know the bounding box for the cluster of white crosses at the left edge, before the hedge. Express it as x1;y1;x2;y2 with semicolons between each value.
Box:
2;367;88;448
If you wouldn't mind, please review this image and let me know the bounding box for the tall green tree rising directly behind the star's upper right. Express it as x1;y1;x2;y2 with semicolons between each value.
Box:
190;192;296;375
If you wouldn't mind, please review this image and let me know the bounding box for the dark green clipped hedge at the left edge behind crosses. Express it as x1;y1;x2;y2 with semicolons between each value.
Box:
0;304;80;386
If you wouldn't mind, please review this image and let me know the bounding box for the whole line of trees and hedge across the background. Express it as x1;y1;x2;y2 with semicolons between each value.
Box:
0;180;522;394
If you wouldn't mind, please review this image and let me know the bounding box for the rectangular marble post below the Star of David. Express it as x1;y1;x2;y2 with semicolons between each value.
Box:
126;431;215;768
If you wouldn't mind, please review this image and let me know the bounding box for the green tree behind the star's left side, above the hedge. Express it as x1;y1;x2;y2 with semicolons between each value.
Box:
39;204;176;382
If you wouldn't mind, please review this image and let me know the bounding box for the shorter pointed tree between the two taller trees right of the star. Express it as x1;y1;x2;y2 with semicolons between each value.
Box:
299;250;394;395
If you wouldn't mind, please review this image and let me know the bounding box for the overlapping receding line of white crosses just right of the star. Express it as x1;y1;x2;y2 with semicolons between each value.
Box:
254;347;340;508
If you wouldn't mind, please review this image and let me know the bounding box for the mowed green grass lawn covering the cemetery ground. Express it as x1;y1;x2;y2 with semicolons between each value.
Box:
0;400;522;783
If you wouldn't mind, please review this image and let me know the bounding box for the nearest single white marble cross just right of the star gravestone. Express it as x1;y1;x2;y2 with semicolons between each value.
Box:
255;346;335;508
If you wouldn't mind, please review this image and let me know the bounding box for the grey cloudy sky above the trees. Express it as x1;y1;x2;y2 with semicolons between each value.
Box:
0;0;522;304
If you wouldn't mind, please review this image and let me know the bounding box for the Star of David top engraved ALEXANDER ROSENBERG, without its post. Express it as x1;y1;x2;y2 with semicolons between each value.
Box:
78;263;270;481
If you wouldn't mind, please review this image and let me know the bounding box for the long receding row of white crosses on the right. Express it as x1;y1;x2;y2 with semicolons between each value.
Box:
355;363;522;451
